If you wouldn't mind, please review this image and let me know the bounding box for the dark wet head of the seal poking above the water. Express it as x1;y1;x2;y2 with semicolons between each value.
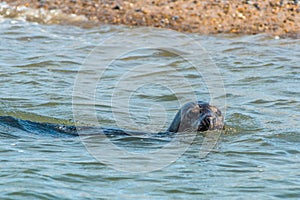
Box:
167;101;224;133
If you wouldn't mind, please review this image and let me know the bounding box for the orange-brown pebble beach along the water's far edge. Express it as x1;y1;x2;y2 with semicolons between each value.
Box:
3;0;300;38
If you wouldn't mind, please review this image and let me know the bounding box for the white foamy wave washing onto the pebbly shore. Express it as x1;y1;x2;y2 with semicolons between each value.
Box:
0;2;88;25
